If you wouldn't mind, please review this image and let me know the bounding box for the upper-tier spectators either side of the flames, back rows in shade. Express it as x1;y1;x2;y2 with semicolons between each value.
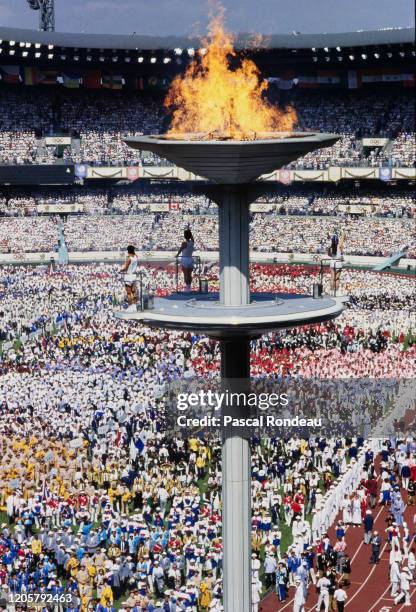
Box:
0;88;416;169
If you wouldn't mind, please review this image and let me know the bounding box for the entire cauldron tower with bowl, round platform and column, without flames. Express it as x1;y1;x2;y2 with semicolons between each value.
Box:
116;133;343;612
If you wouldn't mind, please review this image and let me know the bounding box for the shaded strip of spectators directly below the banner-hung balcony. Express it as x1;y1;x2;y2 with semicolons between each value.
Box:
0;182;415;218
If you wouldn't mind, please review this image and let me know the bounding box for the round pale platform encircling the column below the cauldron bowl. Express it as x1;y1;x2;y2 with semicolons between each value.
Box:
115;293;345;339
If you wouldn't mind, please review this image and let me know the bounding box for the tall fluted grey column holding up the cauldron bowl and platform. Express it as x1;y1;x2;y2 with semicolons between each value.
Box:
217;186;252;612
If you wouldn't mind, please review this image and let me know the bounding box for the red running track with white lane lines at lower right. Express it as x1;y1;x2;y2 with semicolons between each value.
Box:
260;498;416;612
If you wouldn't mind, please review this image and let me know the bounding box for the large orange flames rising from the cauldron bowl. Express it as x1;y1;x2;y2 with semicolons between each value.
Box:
165;15;296;140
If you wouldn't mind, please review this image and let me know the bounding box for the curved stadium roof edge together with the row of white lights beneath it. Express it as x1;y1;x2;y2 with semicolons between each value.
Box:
0;27;415;68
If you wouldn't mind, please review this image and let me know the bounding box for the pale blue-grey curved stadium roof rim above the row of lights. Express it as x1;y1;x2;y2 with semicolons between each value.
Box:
0;27;415;51
